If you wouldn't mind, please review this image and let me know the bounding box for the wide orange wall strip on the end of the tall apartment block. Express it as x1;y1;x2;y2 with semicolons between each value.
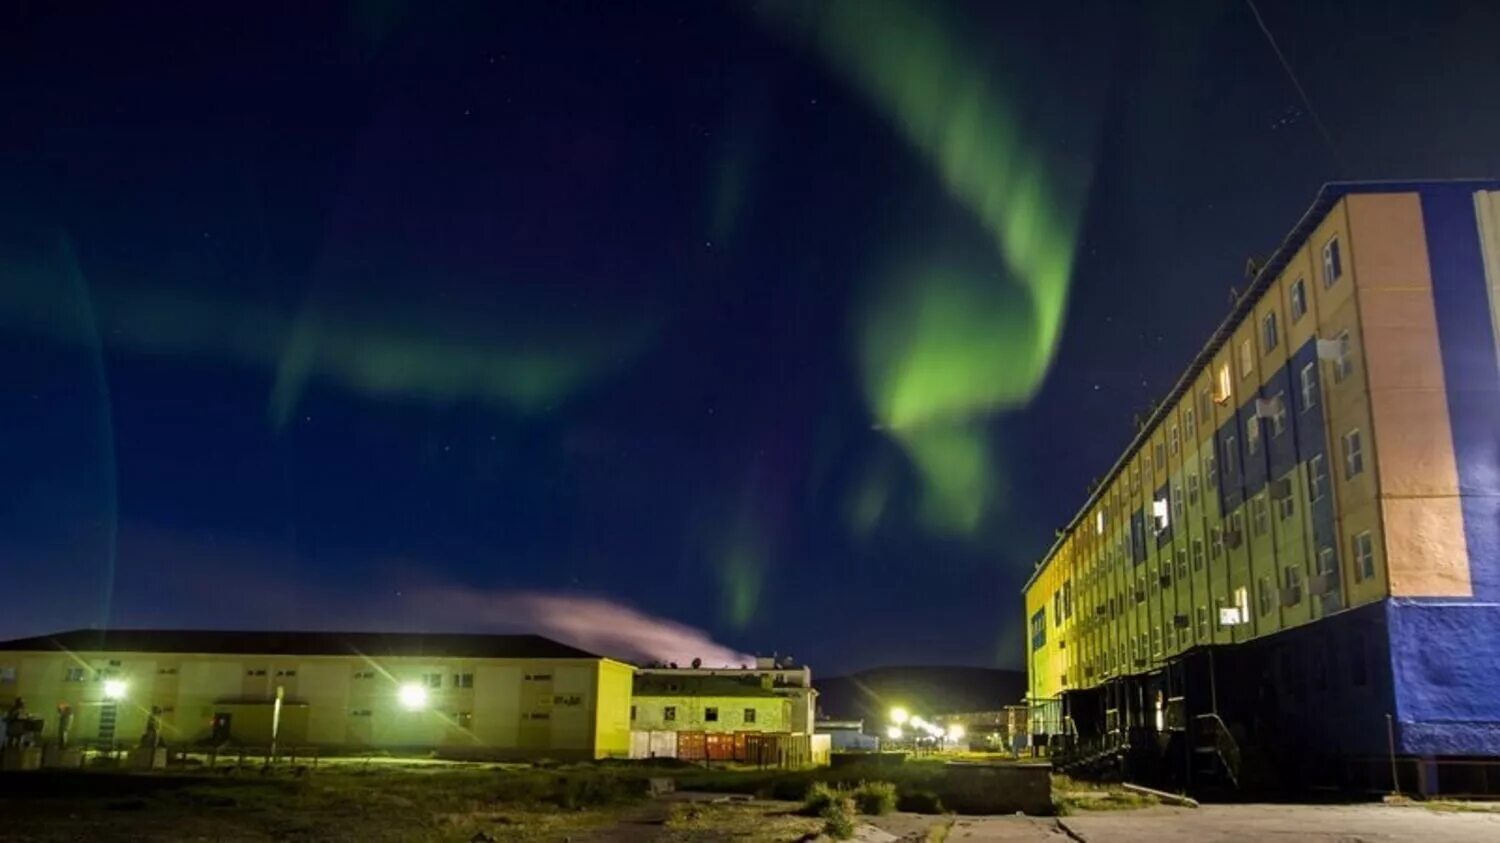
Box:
1347;194;1473;597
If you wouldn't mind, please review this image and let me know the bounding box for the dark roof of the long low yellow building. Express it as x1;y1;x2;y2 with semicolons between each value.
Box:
0;630;600;659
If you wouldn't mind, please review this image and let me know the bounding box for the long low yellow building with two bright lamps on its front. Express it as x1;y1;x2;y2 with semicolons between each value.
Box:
0;630;635;759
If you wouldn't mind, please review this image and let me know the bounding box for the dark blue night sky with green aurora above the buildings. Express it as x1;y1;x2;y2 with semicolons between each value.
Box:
0;0;1500;675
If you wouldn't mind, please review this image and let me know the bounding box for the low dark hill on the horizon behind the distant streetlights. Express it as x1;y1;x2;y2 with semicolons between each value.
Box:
813;668;1026;731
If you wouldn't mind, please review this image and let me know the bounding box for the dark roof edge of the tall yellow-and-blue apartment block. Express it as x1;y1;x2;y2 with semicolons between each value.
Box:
1022;179;1500;594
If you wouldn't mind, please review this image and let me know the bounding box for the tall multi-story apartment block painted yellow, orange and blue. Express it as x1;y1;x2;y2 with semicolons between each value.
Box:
1025;182;1500;791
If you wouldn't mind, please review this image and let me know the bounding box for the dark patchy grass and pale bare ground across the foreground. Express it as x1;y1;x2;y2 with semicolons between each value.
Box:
0;768;1500;843
